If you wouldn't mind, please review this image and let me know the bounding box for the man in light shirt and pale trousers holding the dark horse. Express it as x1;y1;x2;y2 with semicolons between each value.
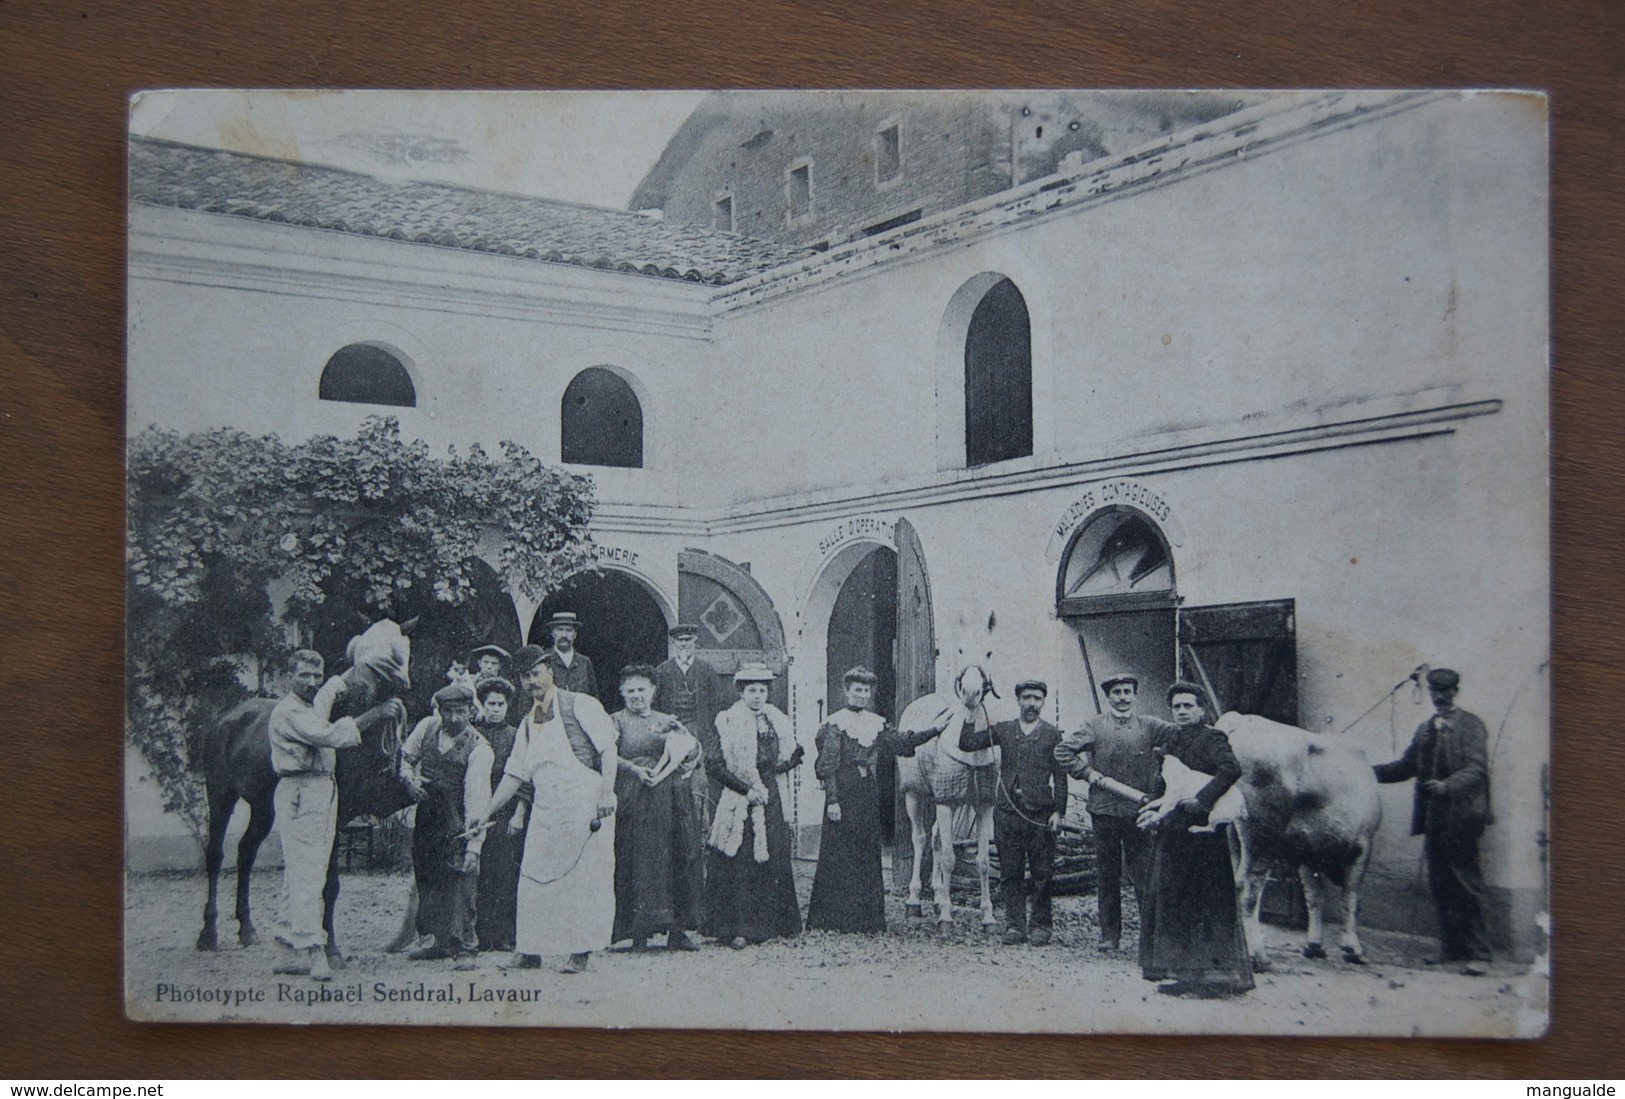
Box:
268;649;361;980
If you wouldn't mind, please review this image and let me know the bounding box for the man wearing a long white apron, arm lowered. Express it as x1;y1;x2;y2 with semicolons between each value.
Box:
486;645;619;974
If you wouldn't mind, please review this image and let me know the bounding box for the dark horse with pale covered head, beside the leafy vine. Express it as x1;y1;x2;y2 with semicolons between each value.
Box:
192;619;418;967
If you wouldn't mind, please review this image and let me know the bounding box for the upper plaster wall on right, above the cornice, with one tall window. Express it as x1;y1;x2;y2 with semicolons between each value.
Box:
707;96;1545;499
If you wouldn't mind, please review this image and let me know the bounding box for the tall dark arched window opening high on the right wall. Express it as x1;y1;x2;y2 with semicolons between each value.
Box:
965;278;1032;467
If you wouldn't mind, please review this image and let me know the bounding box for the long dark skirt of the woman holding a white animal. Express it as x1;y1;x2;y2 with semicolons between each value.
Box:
1139;824;1253;990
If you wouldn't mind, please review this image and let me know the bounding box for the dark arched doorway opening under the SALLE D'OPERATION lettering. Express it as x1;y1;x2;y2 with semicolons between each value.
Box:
824;545;899;844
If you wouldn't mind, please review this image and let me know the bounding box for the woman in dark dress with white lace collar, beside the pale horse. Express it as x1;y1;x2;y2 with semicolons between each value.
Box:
808;667;929;932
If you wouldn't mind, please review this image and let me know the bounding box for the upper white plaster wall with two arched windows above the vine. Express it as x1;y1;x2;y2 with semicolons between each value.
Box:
127;208;713;502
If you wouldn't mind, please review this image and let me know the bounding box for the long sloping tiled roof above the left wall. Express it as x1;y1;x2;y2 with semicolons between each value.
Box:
130;137;806;285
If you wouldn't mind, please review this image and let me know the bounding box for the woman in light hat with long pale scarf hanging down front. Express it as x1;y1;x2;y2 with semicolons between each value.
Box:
700;663;804;949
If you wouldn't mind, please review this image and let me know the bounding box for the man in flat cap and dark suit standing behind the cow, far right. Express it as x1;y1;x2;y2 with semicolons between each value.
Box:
1372;668;1490;977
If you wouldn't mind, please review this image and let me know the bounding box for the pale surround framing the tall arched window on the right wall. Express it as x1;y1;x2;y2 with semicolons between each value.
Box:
936;248;1056;470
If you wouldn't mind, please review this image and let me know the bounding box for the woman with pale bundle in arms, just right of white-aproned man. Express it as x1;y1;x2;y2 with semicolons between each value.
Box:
609;663;705;951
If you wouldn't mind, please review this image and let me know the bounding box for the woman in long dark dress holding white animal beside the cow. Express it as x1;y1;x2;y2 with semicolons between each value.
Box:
1139;683;1253;995
